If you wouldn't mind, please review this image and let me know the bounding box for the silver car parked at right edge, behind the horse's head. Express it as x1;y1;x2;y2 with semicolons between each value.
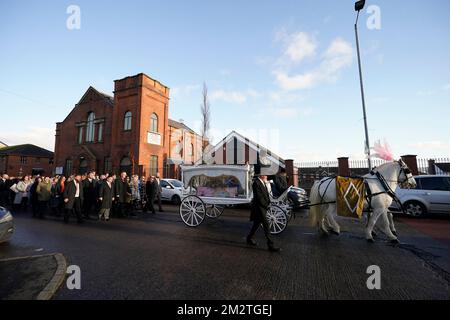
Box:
391;175;450;217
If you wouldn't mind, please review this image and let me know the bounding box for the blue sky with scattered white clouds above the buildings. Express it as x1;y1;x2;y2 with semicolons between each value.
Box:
0;0;450;162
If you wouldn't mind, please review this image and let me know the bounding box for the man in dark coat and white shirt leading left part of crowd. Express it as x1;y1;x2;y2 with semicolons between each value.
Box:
63;174;83;223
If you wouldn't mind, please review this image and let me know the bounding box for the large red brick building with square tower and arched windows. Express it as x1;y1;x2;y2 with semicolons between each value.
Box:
55;73;202;177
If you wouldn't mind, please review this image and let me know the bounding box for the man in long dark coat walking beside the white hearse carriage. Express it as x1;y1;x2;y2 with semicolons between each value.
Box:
247;175;280;251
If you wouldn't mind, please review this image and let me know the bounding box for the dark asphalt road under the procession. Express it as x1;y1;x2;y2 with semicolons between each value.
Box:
0;206;450;299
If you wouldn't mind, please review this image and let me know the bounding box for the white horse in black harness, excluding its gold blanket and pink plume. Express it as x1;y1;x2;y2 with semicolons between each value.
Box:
310;160;416;243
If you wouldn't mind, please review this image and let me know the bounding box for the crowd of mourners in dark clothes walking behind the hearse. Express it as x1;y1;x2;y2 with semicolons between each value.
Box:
0;171;163;223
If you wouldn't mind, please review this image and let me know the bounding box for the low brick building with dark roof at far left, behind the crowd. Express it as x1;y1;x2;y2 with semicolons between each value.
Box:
0;144;53;177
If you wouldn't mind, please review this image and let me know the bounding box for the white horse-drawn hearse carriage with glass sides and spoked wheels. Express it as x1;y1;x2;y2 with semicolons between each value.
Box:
179;165;292;234
